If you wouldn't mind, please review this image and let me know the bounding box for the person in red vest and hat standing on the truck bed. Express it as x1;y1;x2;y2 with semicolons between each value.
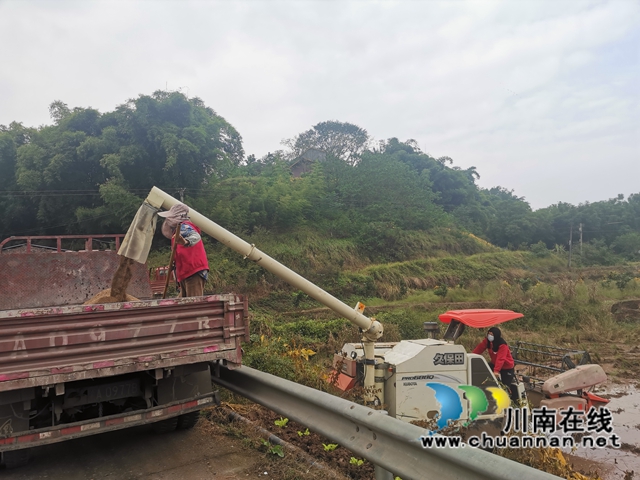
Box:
158;203;209;297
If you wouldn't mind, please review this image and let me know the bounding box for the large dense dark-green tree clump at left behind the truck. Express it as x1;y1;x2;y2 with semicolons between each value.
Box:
0;91;244;233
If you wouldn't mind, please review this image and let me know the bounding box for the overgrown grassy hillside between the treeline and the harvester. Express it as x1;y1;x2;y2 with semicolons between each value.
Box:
149;229;640;387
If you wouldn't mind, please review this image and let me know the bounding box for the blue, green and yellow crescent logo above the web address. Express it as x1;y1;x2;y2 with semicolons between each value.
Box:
426;382;511;429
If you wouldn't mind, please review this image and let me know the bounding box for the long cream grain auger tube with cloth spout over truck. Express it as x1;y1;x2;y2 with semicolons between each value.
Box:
118;187;384;403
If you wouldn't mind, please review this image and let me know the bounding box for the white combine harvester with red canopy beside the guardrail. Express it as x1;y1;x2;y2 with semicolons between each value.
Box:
333;309;609;423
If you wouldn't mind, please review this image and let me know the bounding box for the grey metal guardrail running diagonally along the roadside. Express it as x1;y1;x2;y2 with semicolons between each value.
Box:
212;366;559;480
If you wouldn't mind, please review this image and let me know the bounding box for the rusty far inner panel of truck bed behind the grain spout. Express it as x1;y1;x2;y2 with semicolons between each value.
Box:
0;251;152;310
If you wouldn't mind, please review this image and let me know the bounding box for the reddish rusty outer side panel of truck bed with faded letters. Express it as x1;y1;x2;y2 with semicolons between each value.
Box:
0;294;248;391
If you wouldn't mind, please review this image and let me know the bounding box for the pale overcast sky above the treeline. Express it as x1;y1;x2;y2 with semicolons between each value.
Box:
0;0;640;208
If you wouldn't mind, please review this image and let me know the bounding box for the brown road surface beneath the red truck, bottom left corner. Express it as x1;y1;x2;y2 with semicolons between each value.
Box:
0;419;258;480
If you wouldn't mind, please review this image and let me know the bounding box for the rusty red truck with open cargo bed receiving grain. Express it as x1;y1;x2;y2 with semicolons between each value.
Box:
0;235;249;468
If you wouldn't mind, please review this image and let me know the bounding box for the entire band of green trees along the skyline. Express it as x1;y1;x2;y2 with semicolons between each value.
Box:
0;91;640;263
